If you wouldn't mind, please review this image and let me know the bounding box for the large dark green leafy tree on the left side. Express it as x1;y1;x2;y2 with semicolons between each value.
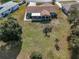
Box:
0;17;22;42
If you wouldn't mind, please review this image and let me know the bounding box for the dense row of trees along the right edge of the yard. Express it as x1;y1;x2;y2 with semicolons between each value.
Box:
68;6;79;59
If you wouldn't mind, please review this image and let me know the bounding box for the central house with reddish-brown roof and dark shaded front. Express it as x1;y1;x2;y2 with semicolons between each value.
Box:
24;2;59;21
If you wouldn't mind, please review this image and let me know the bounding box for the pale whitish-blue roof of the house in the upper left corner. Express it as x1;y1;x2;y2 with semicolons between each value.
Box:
0;1;18;14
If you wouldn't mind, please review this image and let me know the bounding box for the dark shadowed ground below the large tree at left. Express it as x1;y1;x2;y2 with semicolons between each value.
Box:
0;41;22;59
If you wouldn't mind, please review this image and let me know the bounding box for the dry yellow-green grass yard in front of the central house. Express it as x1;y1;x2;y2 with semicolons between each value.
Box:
0;5;70;59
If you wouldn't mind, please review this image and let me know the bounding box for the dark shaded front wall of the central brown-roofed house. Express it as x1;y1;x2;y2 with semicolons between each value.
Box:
26;12;57;20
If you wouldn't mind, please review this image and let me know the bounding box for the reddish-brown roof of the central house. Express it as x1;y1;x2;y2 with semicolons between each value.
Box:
26;5;59;13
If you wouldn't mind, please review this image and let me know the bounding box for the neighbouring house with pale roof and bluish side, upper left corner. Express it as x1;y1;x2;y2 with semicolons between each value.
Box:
0;1;19;17
